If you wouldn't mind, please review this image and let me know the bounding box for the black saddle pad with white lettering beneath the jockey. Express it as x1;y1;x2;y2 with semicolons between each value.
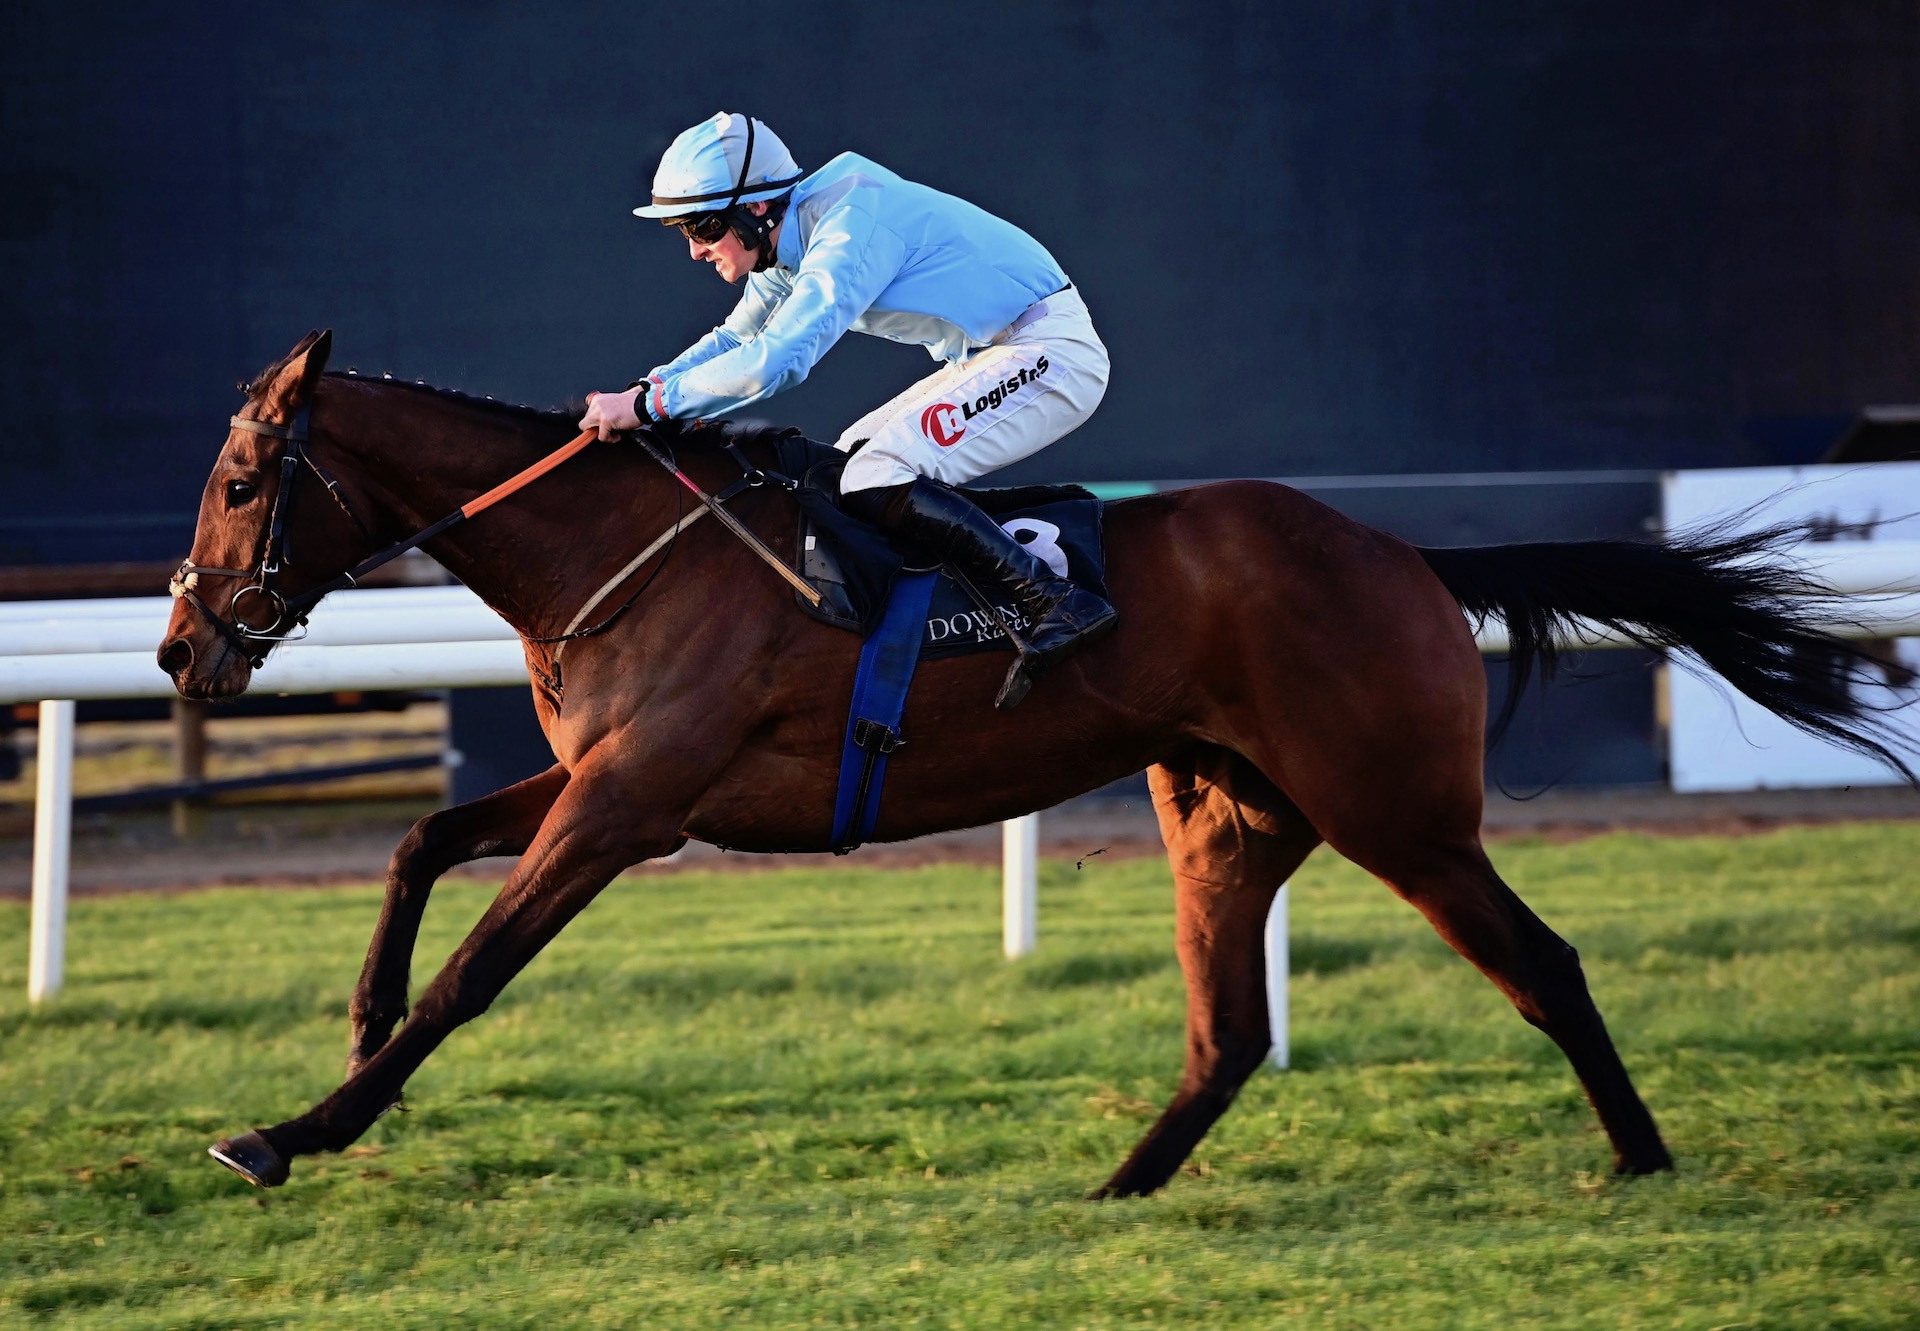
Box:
780;438;1106;657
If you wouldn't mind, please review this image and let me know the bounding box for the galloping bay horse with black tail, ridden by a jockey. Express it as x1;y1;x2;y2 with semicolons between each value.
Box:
159;334;1910;1197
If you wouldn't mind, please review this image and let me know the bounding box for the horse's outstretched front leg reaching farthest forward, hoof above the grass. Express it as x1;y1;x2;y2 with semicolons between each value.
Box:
213;756;685;1187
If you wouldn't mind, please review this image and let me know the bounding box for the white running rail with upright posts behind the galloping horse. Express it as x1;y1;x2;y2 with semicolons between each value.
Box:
11;542;1920;1068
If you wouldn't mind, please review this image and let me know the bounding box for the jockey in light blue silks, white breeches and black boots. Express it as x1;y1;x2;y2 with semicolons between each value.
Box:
580;113;1114;707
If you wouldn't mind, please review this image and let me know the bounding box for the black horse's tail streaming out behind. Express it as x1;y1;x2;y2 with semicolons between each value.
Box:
1421;524;1920;786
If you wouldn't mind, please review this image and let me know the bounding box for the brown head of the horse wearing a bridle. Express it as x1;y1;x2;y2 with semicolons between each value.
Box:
159;332;355;699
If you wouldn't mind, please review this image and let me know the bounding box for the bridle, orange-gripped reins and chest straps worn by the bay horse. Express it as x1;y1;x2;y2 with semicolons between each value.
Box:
167;407;820;670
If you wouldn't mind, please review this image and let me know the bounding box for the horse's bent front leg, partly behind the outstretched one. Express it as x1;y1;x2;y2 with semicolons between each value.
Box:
348;764;566;1076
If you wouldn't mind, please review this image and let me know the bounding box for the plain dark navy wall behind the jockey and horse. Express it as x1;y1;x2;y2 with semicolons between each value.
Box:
0;0;1920;787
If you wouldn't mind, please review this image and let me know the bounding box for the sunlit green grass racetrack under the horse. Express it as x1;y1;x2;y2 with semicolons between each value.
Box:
0;824;1920;1329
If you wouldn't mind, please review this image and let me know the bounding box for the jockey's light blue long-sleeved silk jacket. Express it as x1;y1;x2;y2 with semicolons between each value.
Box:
649;152;1068;419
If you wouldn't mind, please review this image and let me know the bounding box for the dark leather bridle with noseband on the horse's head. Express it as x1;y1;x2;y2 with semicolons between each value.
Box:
167;405;374;670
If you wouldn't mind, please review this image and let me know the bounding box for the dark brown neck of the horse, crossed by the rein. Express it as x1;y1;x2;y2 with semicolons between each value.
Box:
328;384;664;634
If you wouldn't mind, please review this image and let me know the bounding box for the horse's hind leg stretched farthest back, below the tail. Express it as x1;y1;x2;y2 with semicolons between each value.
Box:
1334;839;1672;1174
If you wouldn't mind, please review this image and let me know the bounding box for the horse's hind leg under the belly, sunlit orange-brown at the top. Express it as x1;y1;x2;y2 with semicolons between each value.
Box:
1094;749;1319;1197
